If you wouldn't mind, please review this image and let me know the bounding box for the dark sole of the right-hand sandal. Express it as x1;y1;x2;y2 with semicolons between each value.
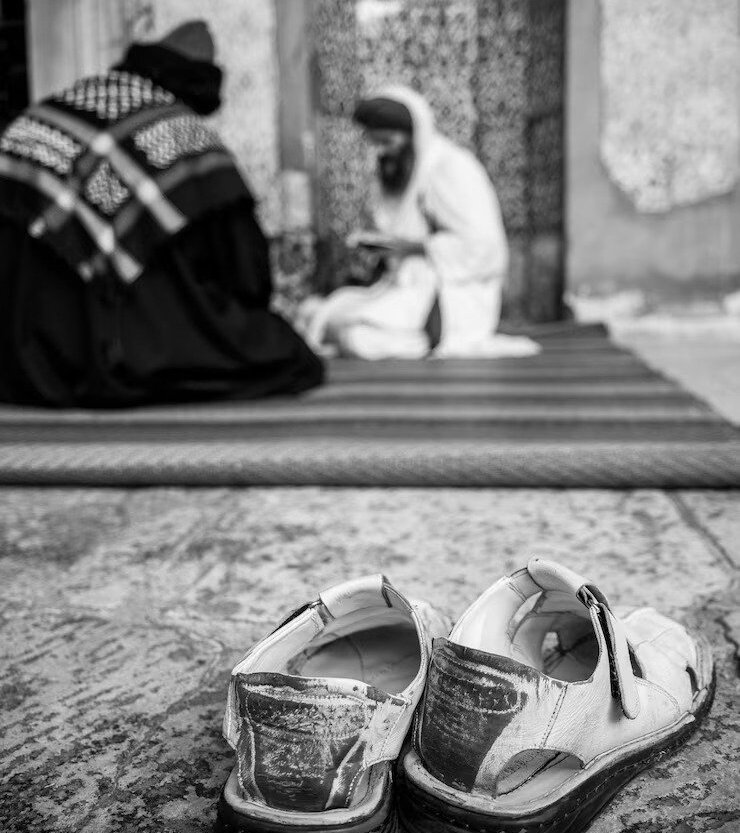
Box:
398;672;716;833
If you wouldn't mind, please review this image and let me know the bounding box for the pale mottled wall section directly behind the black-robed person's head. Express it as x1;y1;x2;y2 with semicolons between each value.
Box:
21;0;280;231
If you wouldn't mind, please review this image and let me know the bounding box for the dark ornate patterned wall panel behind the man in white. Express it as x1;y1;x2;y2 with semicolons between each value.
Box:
313;0;564;318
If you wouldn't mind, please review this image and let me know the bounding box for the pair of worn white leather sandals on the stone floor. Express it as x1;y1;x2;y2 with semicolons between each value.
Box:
218;558;714;833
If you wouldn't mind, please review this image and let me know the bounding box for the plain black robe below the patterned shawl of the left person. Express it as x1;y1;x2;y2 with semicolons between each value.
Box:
0;200;323;407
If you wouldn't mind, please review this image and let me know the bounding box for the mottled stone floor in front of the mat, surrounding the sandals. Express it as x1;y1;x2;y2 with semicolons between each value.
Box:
0;328;740;833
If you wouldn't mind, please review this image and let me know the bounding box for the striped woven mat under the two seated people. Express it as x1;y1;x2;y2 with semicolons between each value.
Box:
0;325;740;488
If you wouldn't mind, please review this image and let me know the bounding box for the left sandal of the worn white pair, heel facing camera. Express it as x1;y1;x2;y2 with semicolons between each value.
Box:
217;575;449;833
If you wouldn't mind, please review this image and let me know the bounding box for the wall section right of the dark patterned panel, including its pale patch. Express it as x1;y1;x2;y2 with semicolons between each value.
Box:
566;0;740;302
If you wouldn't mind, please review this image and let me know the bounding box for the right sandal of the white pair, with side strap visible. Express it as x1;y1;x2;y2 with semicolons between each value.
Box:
399;558;714;833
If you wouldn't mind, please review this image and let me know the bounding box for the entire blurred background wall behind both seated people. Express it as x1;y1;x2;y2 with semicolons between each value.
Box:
0;0;740;320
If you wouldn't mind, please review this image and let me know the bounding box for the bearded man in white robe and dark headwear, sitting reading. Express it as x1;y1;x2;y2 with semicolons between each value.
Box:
299;87;538;359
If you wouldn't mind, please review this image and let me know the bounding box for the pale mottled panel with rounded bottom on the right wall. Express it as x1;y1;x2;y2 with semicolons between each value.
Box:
601;0;740;218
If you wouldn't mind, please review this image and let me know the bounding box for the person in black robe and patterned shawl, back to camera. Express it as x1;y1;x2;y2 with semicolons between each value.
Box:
0;22;323;407
